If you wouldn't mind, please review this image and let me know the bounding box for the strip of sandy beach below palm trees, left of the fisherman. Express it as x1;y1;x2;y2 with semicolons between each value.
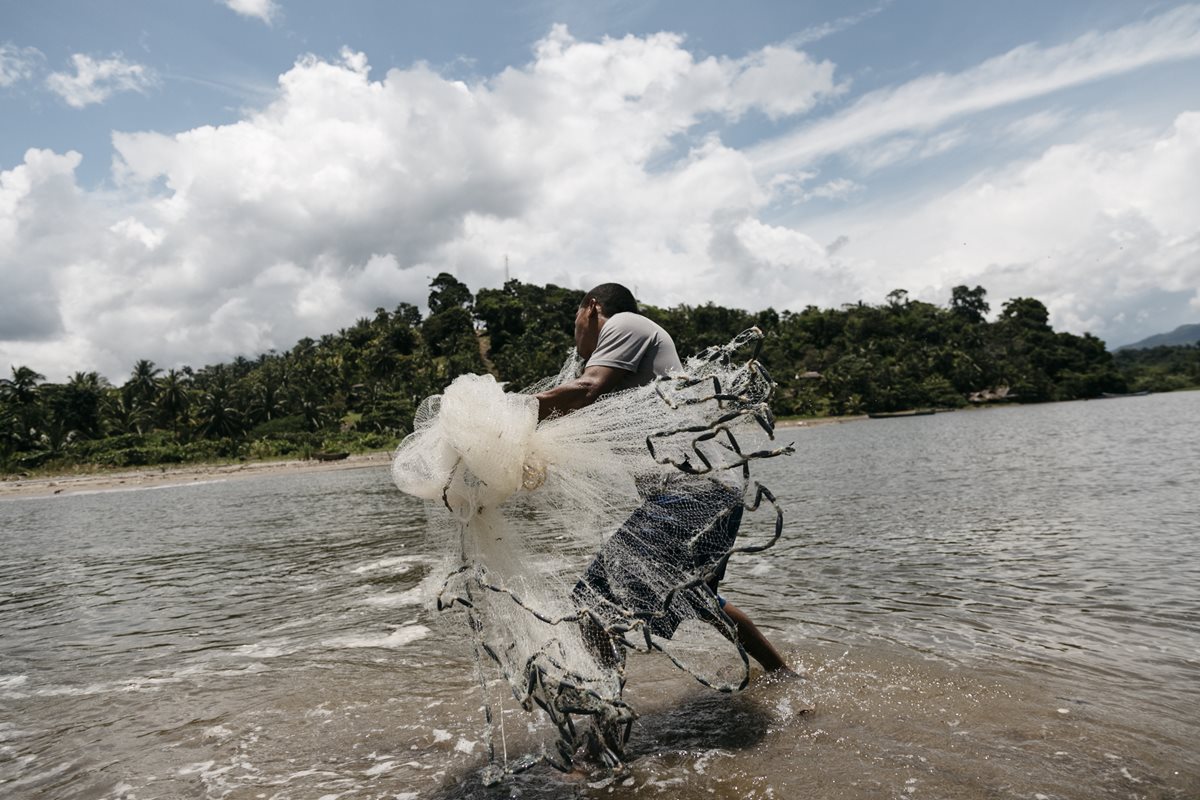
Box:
0;450;391;500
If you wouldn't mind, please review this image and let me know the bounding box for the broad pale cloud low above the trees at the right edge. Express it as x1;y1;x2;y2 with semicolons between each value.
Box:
820;112;1200;344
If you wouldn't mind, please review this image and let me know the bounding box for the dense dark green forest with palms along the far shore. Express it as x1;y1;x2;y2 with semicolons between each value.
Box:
0;273;1200;474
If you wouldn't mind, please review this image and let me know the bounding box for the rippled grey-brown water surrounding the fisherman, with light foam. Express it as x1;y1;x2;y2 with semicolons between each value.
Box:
0;392;1200;800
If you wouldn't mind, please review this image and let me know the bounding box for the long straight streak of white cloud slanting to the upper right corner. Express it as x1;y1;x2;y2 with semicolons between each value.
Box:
750;6;1200;173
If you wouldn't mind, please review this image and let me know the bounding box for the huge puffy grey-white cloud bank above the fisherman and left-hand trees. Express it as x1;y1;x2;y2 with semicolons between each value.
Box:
0;33;836;377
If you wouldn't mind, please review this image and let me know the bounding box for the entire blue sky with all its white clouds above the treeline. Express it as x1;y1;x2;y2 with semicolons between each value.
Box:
0;0;1200;383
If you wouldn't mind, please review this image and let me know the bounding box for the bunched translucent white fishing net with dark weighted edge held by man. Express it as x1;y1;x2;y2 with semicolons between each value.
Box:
392;329;791;780
